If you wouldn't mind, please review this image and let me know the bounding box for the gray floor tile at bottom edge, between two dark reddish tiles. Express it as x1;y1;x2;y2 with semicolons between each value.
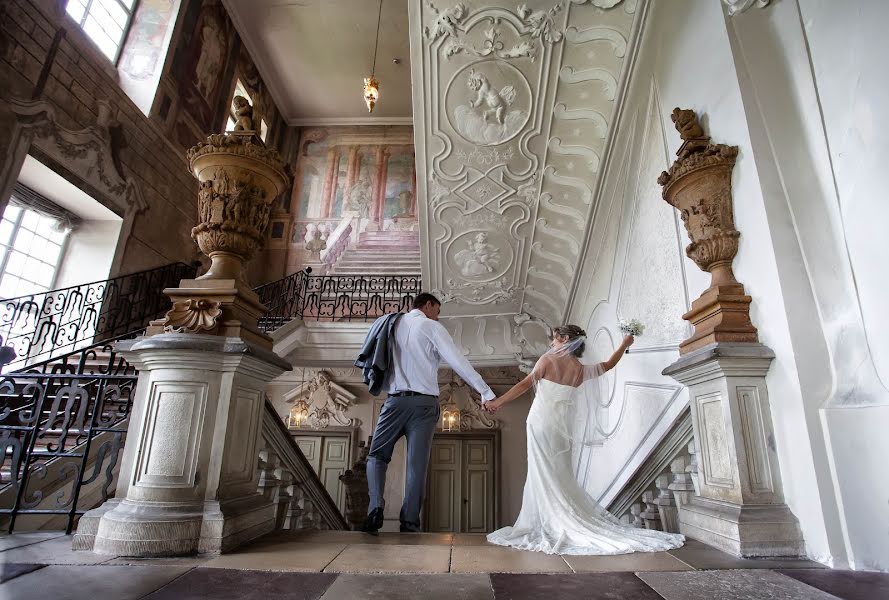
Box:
322;574;494;600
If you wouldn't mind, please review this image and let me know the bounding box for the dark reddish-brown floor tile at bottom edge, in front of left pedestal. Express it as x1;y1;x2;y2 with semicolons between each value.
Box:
145;567;336;600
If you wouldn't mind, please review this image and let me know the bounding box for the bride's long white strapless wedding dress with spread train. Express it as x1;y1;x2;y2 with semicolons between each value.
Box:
488;379;685;555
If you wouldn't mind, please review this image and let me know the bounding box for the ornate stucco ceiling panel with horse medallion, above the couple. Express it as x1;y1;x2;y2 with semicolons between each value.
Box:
410;0;637;358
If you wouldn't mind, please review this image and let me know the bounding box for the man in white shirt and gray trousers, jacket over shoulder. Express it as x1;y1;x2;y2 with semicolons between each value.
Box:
356;293;494;533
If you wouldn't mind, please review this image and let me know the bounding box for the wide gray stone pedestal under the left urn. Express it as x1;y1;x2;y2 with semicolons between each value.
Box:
75;333;290;557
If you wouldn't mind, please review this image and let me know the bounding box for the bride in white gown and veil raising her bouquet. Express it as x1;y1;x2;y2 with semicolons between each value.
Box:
485;325;685;555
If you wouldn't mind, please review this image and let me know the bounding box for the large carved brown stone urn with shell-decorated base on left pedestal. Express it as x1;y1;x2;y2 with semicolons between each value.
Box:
148;130;289;349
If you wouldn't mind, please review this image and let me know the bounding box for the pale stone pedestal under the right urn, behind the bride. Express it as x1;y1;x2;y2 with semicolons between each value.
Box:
663;343;805;557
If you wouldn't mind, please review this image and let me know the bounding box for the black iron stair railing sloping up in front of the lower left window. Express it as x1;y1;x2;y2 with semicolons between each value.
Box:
0;263;197;371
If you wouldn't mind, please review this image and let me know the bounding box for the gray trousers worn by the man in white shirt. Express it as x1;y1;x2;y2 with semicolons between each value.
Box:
367;394;440;527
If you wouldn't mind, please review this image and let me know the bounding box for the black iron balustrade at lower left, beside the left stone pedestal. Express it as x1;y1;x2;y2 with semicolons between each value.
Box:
0;340;137;533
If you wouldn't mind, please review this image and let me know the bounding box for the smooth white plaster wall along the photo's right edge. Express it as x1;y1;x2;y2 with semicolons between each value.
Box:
727;1;889;570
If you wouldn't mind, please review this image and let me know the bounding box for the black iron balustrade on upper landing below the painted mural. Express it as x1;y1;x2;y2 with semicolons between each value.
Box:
255;268;423;331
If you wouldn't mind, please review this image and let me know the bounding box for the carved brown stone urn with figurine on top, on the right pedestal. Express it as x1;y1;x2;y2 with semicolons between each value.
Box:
658;108;758;354
